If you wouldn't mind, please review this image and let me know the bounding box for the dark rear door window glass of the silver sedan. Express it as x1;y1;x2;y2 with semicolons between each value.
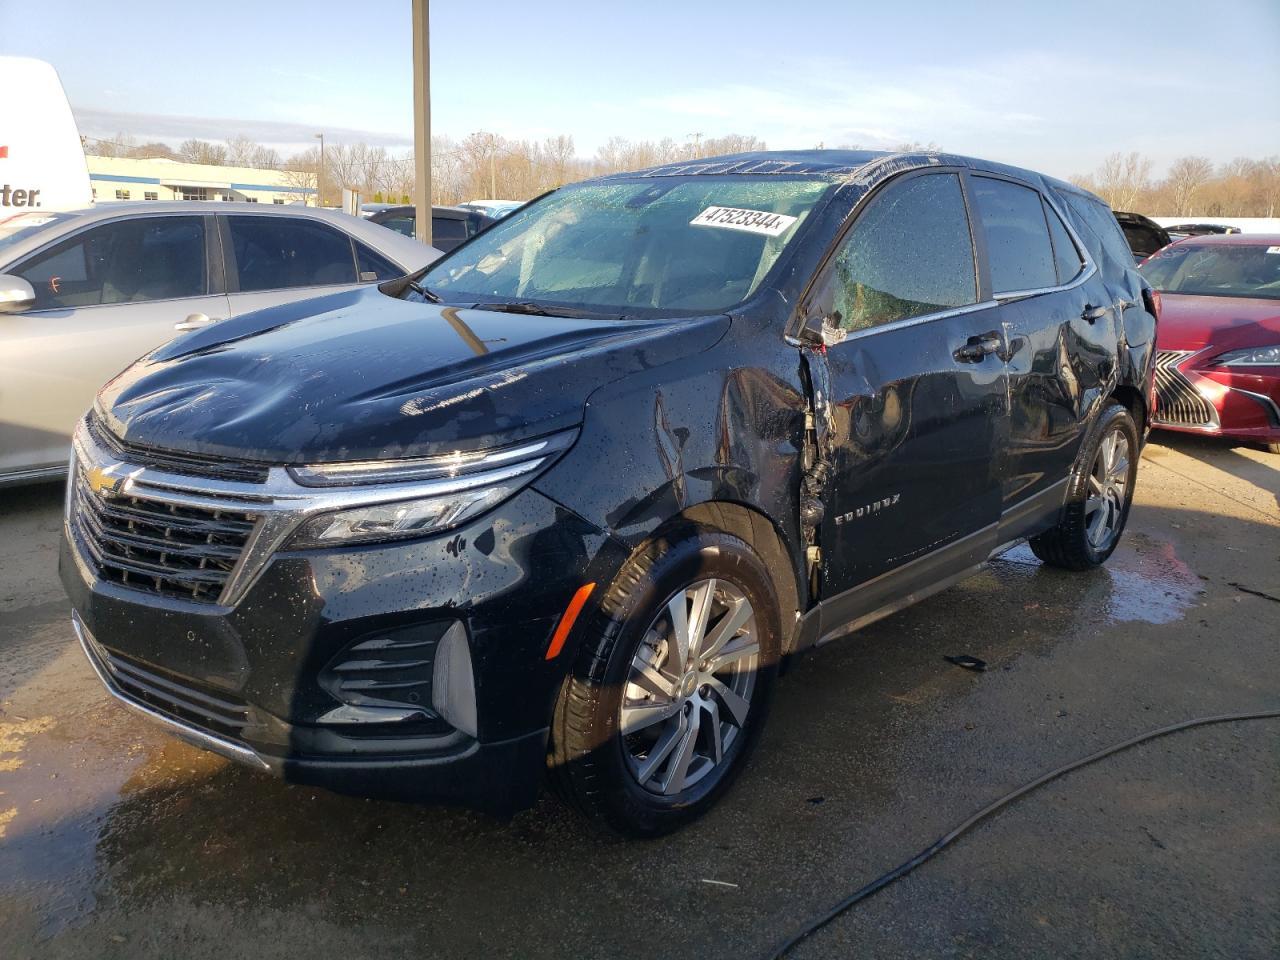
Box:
227;216;356;293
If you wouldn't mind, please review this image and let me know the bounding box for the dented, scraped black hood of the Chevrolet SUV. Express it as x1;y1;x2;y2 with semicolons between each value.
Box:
96;287;730;463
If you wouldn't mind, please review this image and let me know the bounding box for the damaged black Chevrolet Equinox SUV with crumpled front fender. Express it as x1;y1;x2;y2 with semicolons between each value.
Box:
61;151;1156;835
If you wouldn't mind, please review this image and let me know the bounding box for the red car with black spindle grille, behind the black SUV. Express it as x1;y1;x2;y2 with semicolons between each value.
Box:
1139;233;1280;453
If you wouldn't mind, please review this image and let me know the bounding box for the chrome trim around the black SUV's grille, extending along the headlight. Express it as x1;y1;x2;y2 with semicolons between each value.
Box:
65;420;570;607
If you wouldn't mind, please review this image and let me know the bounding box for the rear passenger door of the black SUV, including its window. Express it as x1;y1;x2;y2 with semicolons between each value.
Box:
969;173;1115;541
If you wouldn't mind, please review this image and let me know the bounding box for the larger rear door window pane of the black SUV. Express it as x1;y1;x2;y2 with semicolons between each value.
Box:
970;177;1057;296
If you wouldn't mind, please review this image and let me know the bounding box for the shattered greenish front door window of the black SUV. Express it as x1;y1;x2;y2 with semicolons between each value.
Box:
822;173;978;330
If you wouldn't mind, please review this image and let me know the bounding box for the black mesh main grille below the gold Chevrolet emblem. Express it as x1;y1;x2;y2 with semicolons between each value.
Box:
70;468;256;603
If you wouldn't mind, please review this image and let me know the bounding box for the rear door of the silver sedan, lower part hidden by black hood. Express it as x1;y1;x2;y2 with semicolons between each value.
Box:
218;214;361;316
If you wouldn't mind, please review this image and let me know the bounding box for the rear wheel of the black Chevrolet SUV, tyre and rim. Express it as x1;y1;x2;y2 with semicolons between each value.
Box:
1030;403;1138;570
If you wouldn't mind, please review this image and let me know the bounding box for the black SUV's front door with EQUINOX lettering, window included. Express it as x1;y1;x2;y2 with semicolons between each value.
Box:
805;170;1009;639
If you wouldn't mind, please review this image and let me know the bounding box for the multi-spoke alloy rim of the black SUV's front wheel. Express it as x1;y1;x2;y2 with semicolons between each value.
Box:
620;580;760;796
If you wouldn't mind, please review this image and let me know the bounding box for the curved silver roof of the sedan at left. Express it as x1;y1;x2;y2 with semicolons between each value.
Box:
5;200;442;273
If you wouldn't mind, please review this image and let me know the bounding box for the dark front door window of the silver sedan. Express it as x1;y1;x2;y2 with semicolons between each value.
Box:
14;216;207;310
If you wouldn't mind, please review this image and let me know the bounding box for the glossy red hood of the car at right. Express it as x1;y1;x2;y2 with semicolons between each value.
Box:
1156;293;1280;351
